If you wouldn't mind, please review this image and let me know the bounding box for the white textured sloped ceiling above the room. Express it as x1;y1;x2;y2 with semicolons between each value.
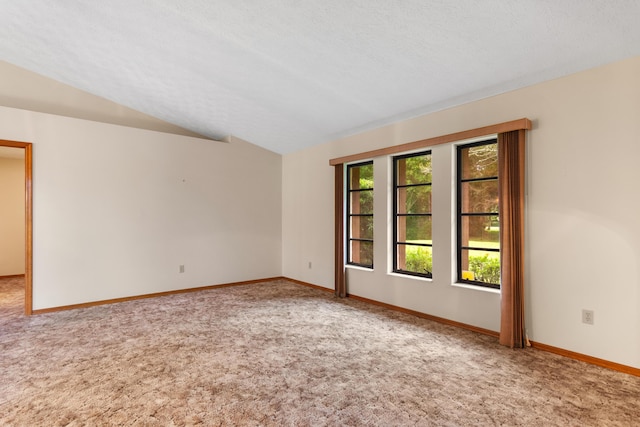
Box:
0;0;640;153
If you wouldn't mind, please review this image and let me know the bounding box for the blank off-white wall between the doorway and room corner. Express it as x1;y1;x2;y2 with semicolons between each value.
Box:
0;107;282;310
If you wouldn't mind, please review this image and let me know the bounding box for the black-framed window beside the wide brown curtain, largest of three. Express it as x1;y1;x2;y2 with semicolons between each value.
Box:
457;139;500;289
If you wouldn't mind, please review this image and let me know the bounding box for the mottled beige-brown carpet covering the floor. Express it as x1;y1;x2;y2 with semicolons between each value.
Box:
0;280;640;426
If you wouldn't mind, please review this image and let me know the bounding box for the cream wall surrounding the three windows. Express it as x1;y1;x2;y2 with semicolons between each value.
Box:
282;57;640;367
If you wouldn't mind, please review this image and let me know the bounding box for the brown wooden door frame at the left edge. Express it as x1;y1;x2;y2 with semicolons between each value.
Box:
0;139;33;316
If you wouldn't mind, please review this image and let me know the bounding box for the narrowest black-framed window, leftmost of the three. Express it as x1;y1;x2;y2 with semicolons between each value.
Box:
347;161;373;268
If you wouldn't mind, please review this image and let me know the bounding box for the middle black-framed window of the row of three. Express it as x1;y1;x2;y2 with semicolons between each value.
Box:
393;151;433;277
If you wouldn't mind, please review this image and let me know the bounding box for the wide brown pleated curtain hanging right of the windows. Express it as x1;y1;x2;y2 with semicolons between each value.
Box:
498;130;528;348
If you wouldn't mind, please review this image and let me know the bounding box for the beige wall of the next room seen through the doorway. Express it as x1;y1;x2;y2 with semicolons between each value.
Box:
0;155;25;276
